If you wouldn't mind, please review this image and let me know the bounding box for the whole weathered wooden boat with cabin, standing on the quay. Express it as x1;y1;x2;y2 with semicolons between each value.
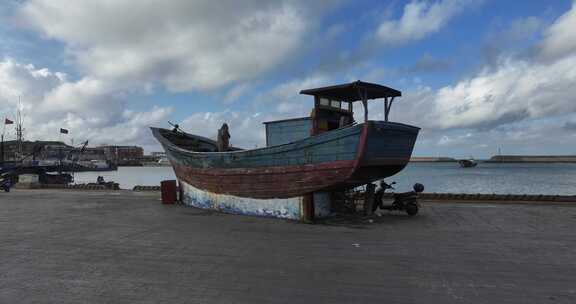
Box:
151;81;420;217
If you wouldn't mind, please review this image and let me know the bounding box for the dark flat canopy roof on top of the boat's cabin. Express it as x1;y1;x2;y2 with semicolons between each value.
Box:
300;80;402;102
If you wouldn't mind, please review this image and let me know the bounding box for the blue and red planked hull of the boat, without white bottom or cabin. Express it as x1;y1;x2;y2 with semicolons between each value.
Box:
152;121;419;199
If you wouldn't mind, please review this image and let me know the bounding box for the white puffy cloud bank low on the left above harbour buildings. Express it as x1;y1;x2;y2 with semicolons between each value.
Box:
0;59;171;147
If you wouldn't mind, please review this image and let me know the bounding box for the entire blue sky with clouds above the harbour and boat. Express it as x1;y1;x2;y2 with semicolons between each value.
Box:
0;0;576;157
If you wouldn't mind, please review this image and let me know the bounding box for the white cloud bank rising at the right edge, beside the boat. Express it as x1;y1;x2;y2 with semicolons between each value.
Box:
428;2;576;128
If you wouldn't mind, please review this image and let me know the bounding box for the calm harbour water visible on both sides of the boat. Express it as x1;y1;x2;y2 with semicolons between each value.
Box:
74;162;576;195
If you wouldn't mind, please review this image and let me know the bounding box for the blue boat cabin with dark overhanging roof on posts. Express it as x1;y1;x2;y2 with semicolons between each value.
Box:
264;80;402;147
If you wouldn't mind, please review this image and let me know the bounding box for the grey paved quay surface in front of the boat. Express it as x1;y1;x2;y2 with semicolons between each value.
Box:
0;190;576;304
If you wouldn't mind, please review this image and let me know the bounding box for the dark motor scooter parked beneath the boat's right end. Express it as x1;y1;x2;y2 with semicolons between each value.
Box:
372;181;424;216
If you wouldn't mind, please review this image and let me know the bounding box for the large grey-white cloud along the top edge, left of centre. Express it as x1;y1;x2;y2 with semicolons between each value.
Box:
20;0;321;92
